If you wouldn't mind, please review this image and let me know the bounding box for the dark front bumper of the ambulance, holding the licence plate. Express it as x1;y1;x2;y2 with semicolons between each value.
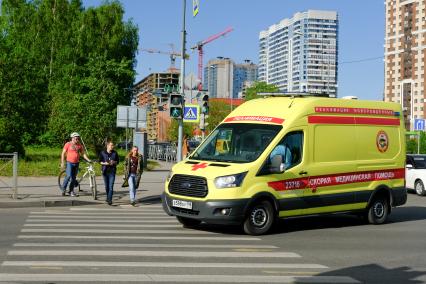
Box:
161;193;249;225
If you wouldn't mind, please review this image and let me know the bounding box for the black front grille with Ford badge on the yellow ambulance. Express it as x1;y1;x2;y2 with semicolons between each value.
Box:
169;175;208;197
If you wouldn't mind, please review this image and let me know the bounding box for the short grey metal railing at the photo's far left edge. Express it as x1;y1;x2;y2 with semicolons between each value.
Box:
0;152;18;199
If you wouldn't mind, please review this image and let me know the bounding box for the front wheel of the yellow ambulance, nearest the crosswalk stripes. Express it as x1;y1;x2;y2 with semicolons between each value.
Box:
244;200;275;236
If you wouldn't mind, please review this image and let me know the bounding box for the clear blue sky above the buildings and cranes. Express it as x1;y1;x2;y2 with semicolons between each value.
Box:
83;0;385;100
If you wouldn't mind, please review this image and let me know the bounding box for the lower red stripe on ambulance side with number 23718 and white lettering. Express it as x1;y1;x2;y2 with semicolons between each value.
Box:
268;168;405;191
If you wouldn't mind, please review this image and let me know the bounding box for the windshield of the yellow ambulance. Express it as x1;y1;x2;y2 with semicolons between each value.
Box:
190;123;282;163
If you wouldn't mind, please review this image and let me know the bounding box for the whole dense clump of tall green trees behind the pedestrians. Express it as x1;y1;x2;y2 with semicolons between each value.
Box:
0;0;138;152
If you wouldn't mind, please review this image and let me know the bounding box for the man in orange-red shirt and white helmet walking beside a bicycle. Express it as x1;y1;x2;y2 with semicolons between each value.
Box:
61;132;90;196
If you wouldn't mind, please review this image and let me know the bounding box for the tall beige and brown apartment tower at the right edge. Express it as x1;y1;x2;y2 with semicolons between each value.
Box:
384;0;426;130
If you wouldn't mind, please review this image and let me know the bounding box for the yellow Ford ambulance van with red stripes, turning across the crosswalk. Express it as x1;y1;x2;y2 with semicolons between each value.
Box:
162;95;407;235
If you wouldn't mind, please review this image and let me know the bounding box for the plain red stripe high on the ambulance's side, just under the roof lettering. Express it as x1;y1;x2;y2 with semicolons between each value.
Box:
308;115;400;125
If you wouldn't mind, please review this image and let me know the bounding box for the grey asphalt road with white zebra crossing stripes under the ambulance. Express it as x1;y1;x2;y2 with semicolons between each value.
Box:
0;194;426;283
